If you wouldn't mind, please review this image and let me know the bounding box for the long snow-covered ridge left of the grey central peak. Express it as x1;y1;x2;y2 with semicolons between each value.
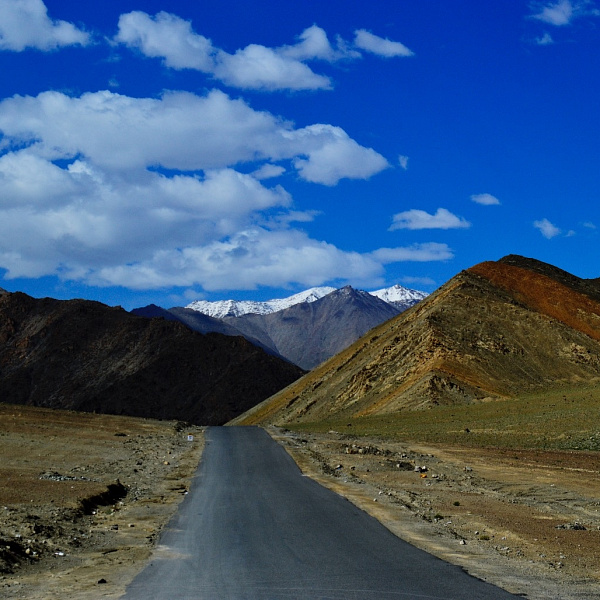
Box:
185;287;336;319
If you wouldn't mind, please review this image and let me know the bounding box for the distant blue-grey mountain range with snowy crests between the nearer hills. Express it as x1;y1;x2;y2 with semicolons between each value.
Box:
132;285;427;370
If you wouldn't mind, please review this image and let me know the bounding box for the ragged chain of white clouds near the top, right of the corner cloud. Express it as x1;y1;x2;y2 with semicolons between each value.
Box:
114;11;412;91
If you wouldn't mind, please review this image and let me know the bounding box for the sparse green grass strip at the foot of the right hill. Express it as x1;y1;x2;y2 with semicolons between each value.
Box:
287;383;600;451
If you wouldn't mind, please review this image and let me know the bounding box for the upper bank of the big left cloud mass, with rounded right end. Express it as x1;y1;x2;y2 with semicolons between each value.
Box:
0;90;387;185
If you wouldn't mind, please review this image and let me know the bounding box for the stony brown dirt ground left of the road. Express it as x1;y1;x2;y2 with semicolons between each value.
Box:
0;404;203;600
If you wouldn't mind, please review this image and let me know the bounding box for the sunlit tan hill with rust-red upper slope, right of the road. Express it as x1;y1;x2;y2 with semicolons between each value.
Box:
237;256;600;424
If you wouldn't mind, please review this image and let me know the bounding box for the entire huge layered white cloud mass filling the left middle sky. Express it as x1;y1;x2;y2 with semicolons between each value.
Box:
0;91;424;290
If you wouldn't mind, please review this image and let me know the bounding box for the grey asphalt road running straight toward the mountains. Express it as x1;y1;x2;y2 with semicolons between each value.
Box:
123;427;516;600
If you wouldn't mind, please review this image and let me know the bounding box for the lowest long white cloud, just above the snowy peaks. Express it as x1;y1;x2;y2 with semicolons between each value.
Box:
92;228;451;291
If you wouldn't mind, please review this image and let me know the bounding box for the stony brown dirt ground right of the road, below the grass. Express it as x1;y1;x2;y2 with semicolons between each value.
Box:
268;428;600;600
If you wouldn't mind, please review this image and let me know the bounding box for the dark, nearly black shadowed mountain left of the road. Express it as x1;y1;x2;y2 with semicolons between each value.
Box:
0;293;302;424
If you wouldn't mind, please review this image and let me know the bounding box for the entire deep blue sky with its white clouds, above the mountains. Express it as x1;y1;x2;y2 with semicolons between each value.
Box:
0;0;600;309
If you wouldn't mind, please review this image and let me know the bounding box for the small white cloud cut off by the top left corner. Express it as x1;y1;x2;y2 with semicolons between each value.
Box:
0;0;91;52
